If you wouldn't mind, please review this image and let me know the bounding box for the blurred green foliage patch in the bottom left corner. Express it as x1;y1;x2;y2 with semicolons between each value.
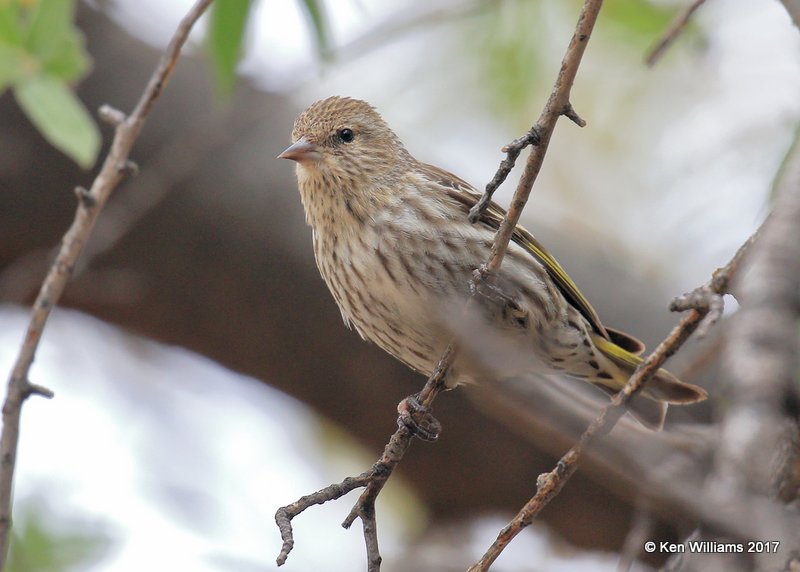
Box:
6;501;112;572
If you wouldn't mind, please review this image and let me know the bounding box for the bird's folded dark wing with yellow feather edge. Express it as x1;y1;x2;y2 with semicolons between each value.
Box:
420;163;609;339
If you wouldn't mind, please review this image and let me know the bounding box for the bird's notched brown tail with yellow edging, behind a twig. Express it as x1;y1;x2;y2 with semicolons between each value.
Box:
591;333;708;430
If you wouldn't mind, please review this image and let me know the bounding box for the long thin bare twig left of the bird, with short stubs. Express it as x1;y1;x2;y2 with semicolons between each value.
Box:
0;0;212;570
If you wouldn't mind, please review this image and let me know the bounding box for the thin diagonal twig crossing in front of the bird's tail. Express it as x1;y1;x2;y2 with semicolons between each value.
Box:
468;220;763;572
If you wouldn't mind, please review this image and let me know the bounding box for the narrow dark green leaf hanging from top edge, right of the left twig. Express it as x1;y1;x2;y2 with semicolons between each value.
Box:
208;0;252;96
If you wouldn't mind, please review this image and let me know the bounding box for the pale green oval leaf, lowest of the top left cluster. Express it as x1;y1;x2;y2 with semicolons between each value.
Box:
14;75;100;169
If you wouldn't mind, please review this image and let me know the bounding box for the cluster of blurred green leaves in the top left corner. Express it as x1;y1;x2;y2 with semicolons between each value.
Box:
0;0;100;169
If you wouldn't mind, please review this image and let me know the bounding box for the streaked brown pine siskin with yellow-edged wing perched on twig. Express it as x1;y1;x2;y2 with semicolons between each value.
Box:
278;97;707;428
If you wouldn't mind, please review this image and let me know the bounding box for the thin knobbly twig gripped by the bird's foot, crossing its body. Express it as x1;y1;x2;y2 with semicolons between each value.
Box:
275;0;602;572
